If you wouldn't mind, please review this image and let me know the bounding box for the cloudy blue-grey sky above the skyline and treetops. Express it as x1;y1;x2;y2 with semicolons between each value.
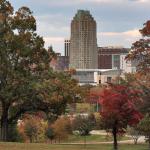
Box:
10;0;150;54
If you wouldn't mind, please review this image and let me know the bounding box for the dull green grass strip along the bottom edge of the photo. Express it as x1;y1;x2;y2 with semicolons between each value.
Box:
0;143;148;150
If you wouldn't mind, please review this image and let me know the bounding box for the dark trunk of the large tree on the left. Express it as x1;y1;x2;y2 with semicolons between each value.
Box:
0;105;8;142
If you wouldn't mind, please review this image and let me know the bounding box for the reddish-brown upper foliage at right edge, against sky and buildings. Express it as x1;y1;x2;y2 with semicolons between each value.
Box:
127;20;150;74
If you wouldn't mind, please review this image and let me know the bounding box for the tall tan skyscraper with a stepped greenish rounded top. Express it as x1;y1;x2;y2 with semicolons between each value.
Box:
70;10;98;69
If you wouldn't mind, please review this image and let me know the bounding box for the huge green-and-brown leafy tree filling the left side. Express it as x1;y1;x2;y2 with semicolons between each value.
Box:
0;0;80;141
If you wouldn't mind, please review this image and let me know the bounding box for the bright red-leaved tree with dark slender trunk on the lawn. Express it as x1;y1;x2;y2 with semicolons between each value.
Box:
92;85;142;150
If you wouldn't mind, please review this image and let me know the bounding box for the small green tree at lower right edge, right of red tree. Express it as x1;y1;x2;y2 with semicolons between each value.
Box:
138;114;150;149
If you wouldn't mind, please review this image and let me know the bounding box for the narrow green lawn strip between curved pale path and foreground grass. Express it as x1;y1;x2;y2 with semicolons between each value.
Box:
61;135;131;143
